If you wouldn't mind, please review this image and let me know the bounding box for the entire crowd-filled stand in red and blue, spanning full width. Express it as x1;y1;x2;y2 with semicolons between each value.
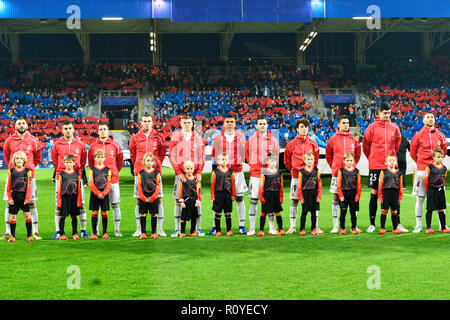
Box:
0;57;450;157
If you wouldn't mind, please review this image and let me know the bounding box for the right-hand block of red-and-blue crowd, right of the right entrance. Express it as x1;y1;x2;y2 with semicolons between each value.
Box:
357;57;450;140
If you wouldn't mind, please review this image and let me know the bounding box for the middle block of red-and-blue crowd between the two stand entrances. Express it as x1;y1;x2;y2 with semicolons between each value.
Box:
149;66;318;142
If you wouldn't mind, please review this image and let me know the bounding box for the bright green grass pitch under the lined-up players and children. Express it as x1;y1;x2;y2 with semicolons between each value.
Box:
0;168;450;300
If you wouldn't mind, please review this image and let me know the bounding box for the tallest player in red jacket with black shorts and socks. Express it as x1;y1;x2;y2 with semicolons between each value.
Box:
363;102;402;232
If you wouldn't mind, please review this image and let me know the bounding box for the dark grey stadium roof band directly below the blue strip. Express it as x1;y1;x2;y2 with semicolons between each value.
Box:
0;18;450;34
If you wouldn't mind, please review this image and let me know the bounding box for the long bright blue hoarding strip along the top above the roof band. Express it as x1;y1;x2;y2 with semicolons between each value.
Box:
0;0;450;22
